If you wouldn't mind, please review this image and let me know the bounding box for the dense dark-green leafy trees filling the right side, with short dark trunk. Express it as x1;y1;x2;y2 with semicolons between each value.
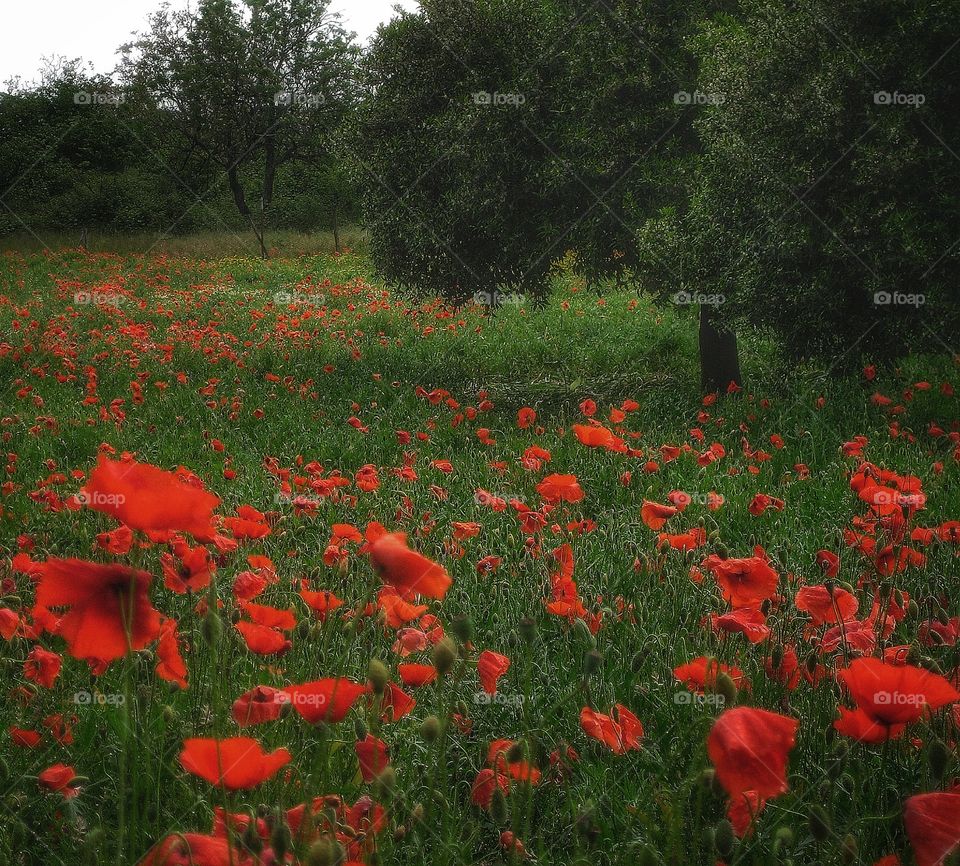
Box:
356;0;960;389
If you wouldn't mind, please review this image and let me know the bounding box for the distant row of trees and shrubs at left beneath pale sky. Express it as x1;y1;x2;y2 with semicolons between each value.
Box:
0;0;360;251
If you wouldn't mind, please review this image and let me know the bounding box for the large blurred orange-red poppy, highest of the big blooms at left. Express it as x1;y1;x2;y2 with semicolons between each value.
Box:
80;454;220;541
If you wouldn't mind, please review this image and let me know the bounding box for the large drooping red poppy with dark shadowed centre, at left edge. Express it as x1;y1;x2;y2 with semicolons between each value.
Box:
34;558;160;662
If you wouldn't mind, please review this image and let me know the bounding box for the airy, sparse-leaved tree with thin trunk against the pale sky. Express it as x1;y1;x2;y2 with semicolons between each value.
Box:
123;0;358;257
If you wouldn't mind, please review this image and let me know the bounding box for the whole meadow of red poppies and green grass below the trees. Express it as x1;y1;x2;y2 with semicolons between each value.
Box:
0;246;960;866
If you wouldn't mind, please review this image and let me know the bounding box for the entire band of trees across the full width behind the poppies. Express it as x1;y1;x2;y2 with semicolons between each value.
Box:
0;0;960;388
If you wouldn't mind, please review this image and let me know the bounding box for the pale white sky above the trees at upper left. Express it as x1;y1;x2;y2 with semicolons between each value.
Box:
0;0;417;84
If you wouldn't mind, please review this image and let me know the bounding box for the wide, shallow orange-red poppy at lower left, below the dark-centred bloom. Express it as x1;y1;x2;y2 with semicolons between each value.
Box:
180;737;291;791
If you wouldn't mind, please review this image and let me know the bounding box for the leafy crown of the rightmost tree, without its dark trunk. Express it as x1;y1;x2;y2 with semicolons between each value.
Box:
676;0;960;364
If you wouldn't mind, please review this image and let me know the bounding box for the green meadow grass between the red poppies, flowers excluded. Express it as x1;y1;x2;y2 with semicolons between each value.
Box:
0;243;960;866
